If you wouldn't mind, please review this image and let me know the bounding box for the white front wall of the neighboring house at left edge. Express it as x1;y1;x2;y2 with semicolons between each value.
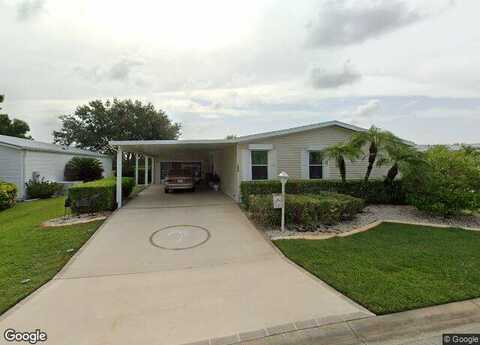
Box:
0;146;23;198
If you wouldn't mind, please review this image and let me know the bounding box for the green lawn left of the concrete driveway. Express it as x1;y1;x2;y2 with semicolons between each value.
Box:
0;198;102;314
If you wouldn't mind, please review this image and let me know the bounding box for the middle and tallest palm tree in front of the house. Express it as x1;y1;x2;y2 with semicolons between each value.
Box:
351;126;402;182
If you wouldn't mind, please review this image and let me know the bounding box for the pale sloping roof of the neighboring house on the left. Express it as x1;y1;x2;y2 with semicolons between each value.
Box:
0;135;108;157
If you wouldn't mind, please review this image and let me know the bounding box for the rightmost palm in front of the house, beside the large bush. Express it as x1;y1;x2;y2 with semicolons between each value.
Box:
377;141;427;183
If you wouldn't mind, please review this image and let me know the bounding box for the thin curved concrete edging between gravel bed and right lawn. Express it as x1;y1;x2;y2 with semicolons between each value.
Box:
271;219;480;241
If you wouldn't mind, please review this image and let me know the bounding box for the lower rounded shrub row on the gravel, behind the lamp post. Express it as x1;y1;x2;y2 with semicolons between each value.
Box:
249;192;365;229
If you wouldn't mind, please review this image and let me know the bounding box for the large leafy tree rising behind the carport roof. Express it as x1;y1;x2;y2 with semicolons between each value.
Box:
53;99;181;154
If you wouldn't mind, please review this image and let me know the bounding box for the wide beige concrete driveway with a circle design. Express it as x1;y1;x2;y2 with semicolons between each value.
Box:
0;186;369;345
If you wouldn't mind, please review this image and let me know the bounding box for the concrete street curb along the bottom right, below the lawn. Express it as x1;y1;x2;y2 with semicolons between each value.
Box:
184;299;480;345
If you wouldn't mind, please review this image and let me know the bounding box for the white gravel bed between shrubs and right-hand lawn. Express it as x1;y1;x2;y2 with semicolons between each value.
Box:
264;205;480;237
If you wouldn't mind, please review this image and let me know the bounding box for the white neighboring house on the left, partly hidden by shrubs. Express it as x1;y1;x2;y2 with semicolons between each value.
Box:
0;135;112;198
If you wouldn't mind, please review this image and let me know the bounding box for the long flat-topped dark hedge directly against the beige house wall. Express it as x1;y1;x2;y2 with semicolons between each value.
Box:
240;180;406;209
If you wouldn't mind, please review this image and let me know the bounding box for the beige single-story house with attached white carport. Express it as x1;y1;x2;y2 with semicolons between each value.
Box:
110;121;396;206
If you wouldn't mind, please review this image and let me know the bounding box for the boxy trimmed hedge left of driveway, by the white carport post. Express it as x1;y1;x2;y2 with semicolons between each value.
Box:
68;177;135;213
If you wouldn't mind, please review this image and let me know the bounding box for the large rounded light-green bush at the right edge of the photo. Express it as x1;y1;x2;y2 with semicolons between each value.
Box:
404;146;480;217
